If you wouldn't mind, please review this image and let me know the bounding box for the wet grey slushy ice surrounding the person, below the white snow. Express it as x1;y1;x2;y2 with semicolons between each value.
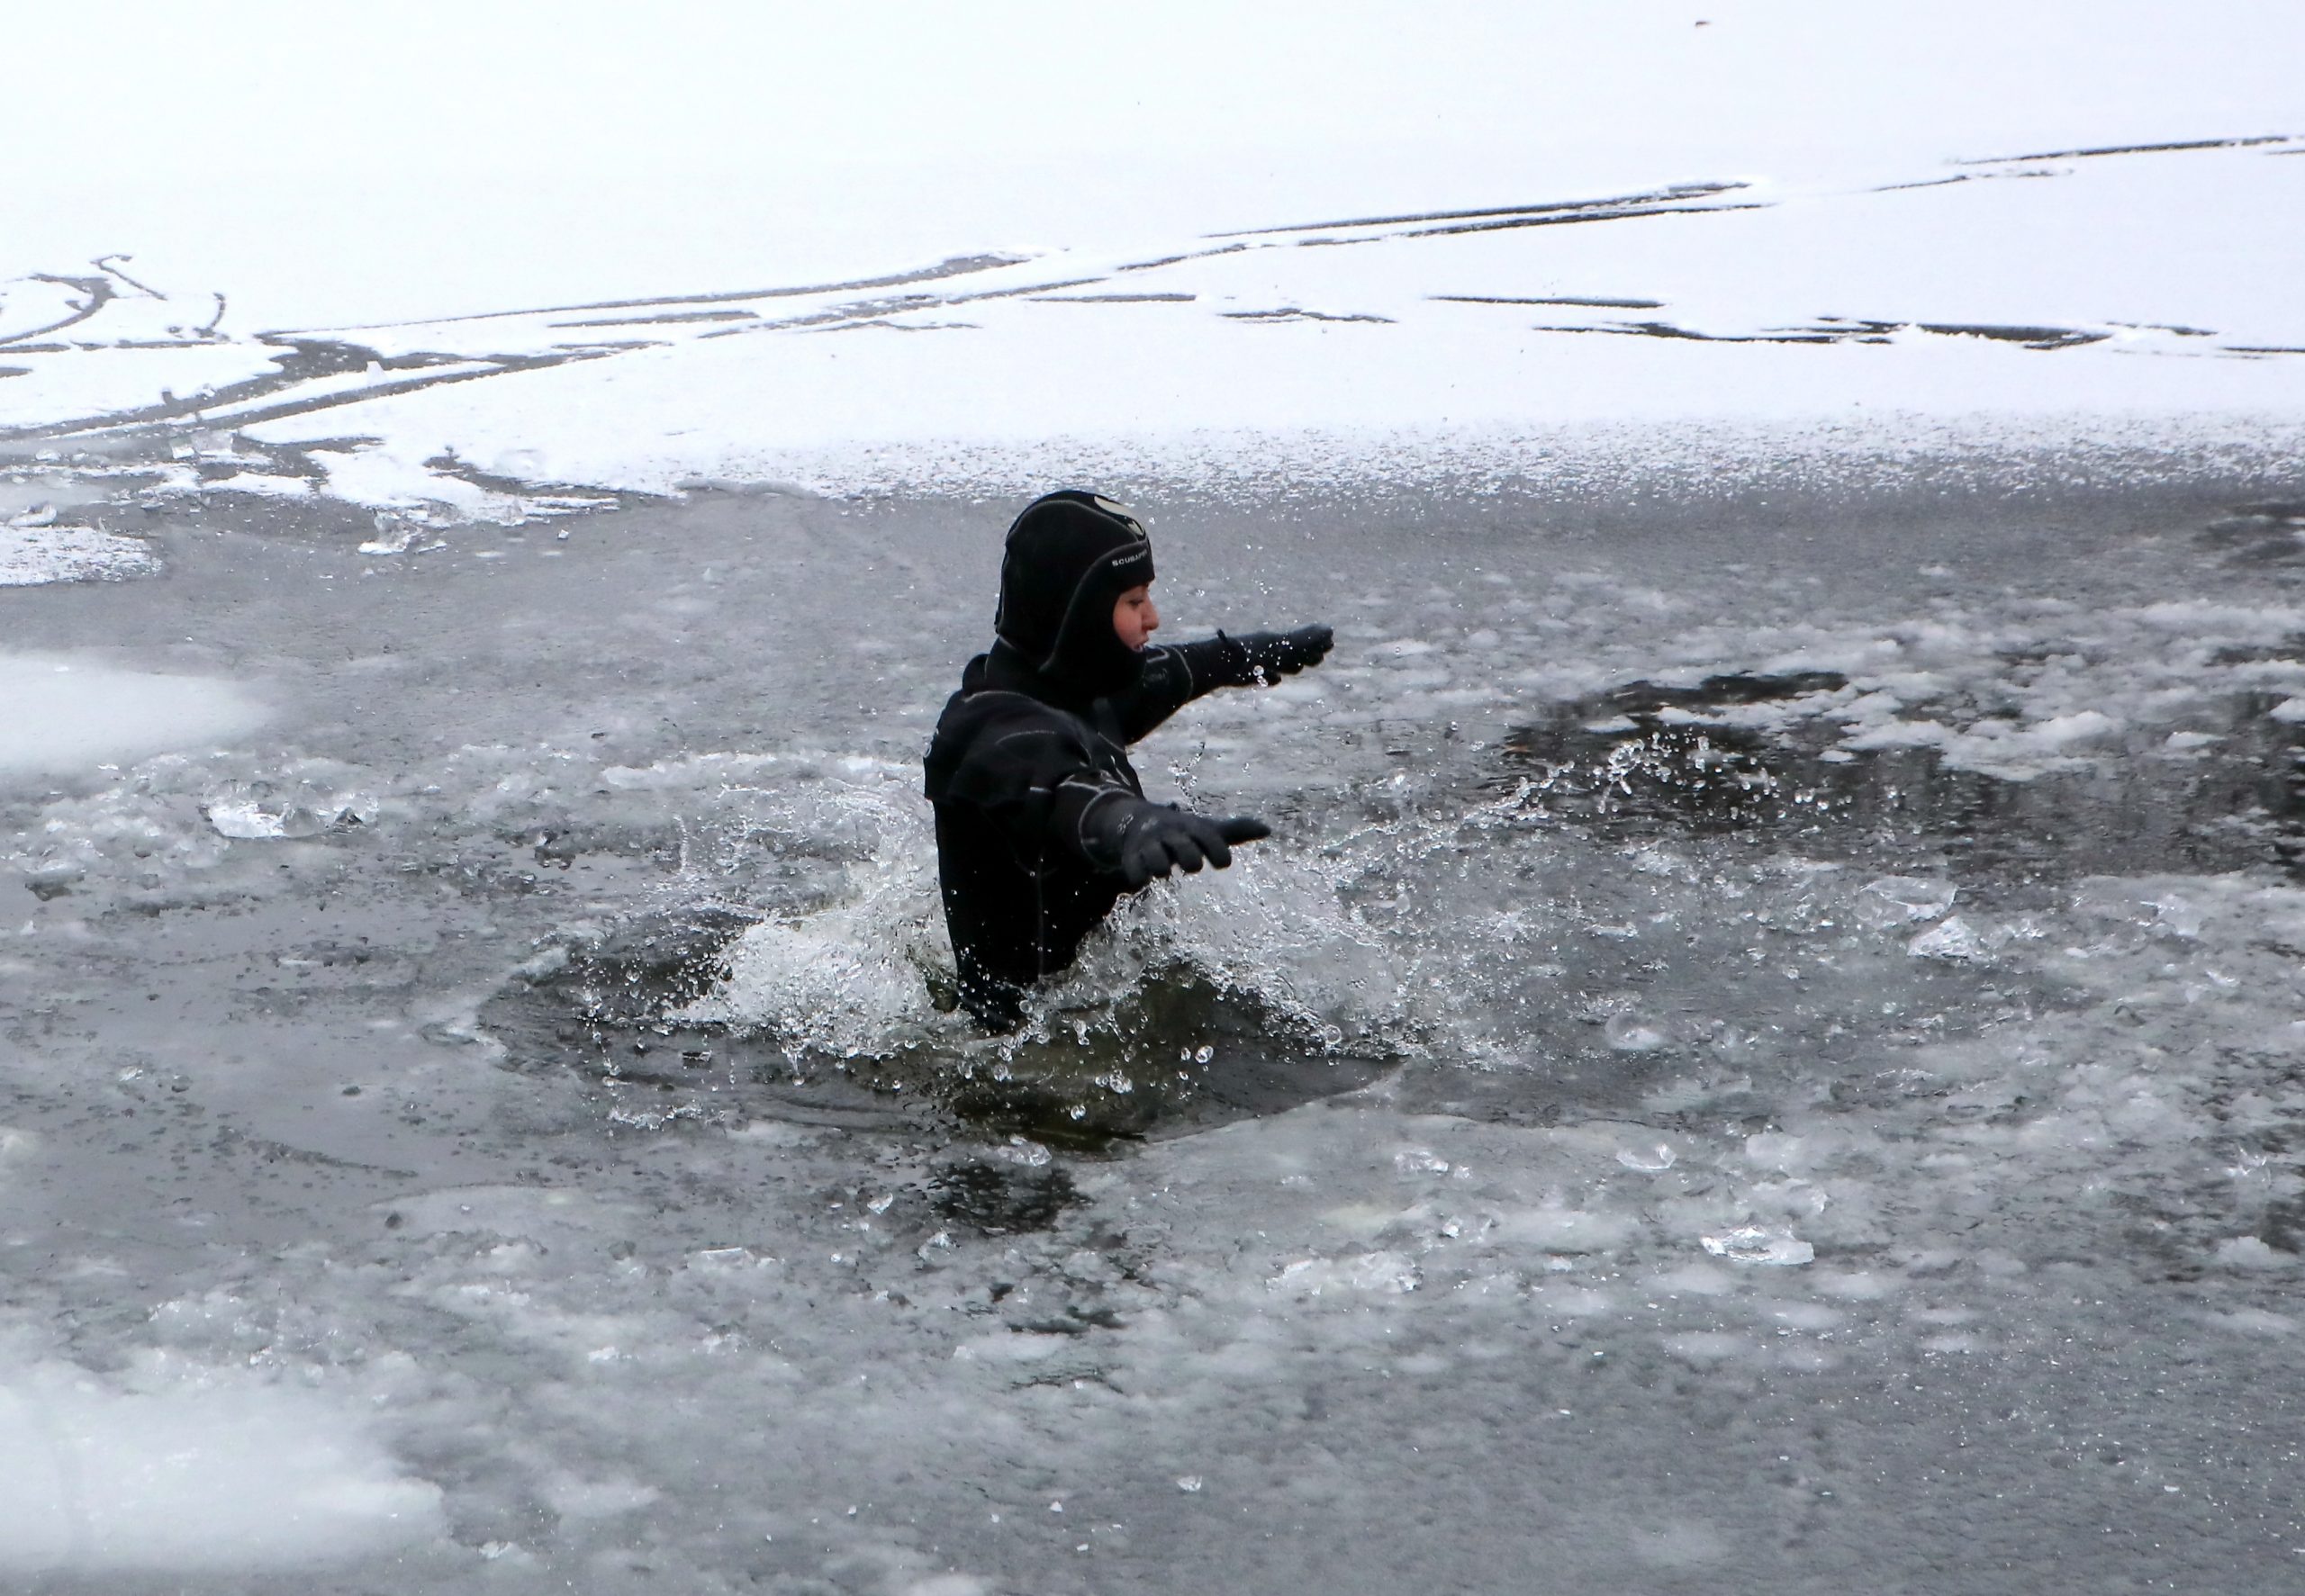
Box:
0;463;2305;1593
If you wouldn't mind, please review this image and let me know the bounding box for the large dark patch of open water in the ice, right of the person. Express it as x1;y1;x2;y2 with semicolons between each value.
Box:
1487;672;2305;884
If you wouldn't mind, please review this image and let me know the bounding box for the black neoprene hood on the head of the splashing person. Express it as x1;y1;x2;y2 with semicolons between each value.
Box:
993;488;1152;702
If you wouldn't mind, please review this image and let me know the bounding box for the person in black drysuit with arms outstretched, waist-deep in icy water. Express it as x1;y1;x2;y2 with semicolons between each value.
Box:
927;491;1330;1032
